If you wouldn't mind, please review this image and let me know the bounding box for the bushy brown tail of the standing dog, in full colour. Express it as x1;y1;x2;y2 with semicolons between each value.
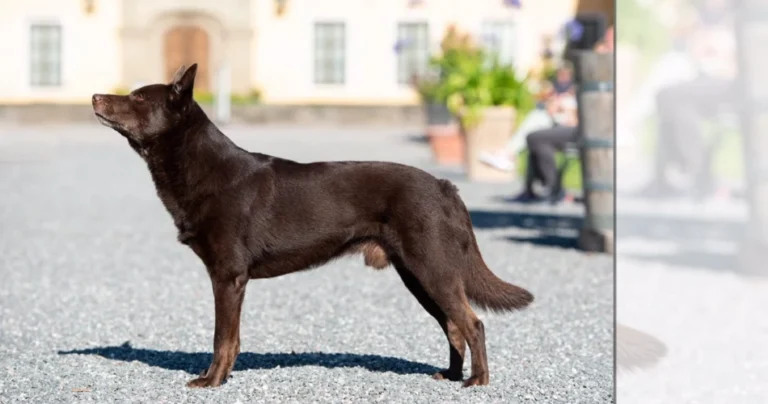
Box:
440;180;533;312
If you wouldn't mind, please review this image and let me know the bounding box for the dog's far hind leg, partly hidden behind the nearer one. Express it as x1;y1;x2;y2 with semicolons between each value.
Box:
397;267;466;381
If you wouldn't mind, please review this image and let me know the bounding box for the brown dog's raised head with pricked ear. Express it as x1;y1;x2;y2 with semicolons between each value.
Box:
91;64;197;145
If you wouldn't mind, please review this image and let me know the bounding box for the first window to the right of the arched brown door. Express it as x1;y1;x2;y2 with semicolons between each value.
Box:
315;22;347;84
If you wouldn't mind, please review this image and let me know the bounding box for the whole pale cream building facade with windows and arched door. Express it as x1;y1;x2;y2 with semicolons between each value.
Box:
0;0;613;105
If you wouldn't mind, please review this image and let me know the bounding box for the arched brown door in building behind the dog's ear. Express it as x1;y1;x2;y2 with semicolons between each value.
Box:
163;25;211;91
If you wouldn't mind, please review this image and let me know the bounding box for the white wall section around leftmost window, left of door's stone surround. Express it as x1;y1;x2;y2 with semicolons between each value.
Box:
0;0;120;102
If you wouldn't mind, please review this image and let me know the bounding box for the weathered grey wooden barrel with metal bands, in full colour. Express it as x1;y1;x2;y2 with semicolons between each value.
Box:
576;51;614;253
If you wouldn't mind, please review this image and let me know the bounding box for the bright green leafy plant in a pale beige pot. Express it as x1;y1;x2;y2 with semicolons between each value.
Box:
441;46;536;181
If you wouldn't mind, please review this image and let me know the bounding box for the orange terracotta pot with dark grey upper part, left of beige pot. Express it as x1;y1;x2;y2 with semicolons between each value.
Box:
425;104;466;165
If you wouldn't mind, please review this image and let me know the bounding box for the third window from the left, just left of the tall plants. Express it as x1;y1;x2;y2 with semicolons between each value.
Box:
395;22;429;84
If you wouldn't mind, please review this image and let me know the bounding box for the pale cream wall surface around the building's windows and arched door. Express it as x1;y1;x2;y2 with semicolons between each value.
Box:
0;0;576;104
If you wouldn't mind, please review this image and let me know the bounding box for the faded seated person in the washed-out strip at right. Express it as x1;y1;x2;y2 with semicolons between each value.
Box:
635;0;737;198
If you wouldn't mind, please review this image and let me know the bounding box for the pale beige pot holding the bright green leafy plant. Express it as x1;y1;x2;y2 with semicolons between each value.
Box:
462;107;516;182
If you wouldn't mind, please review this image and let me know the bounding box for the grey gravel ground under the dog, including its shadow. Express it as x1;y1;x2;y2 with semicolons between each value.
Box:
0;126;613;404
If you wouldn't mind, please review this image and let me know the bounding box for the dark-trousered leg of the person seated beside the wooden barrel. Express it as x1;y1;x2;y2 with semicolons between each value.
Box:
527;126;578;198
